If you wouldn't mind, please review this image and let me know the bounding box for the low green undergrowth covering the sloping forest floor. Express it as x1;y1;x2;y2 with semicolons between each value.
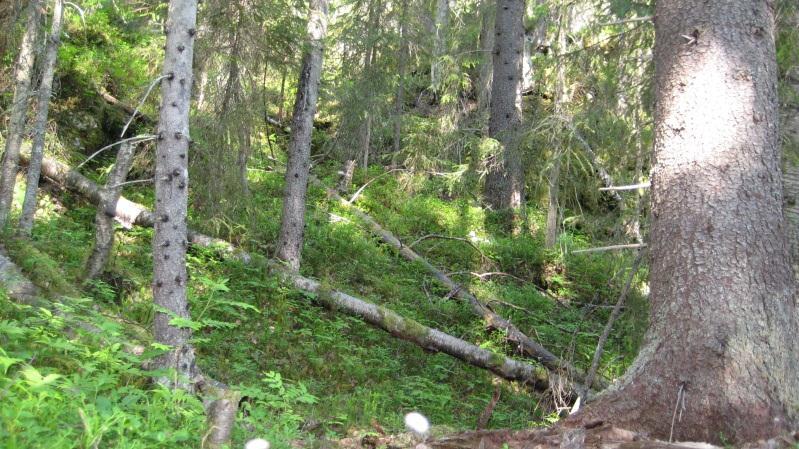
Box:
0;151;644;447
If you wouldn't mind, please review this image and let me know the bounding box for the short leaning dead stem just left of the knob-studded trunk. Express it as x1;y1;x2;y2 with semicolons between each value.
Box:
83;142;136;280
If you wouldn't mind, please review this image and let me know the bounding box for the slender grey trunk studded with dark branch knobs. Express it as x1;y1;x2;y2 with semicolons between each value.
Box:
153;0;198;391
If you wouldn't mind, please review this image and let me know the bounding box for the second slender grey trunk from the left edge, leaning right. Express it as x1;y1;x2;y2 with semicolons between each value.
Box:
19;0;64;237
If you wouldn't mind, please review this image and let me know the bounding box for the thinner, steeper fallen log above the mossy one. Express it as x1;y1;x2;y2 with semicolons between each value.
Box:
311;176;608;388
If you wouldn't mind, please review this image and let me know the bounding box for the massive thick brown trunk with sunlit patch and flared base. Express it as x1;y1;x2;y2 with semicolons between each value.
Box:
576;0;799;444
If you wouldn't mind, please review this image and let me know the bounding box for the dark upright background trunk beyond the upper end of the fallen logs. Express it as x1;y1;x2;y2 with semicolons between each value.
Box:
484;0;524;215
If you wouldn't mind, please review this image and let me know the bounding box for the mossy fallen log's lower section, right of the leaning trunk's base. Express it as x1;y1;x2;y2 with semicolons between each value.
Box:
277;269;549;390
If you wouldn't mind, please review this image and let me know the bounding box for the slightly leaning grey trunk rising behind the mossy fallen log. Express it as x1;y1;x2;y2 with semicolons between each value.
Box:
276;0;328;271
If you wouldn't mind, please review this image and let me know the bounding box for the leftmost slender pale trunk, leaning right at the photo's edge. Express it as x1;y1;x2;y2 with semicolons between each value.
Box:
0;0;42;228
